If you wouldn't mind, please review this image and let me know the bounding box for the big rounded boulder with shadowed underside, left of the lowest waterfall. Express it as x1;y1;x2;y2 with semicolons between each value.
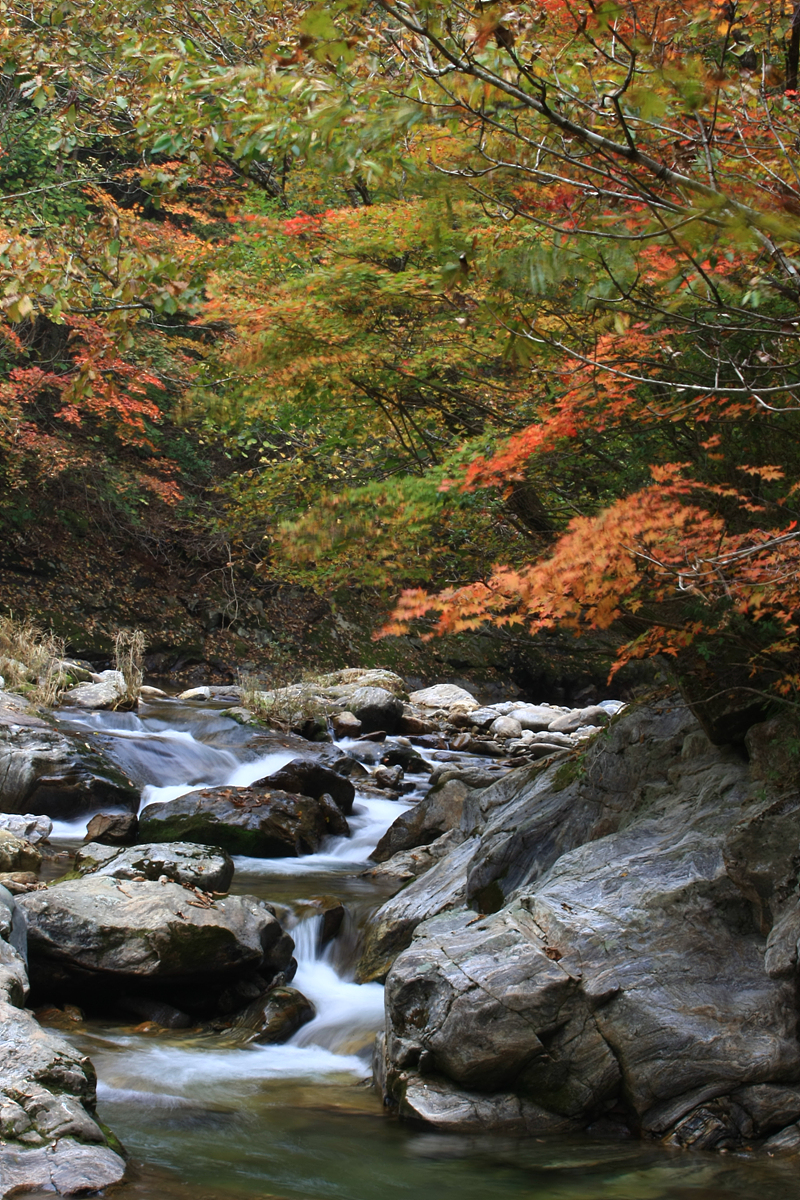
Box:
17;875;294;1013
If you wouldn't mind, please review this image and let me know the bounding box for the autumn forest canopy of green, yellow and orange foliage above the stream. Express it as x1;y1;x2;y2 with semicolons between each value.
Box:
0;0;800;700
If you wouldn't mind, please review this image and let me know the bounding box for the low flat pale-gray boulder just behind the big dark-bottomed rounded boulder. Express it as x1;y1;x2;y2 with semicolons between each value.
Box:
74;841;234;893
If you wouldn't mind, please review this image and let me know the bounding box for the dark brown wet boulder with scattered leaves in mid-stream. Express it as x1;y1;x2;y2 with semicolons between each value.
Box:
139;786;349;858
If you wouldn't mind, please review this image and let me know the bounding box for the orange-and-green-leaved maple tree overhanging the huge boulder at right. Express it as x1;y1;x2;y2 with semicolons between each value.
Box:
304;4;800;692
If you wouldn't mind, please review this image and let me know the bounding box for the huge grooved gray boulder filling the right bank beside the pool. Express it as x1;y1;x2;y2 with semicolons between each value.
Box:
377;702;800;1148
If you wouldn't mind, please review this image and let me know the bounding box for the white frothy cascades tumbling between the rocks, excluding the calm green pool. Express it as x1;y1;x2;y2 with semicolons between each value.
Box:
54;703;402;1108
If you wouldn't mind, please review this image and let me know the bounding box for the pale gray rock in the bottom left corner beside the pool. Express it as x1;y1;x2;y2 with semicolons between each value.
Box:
0;888;125;1196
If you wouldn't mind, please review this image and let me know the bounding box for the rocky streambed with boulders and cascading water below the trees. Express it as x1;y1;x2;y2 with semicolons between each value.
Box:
0;672;800;1200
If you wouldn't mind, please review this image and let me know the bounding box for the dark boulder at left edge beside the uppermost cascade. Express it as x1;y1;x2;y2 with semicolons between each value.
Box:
0;722;139;821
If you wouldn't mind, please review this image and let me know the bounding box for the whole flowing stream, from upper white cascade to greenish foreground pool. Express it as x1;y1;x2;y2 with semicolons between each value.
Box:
47;701;796;1200
